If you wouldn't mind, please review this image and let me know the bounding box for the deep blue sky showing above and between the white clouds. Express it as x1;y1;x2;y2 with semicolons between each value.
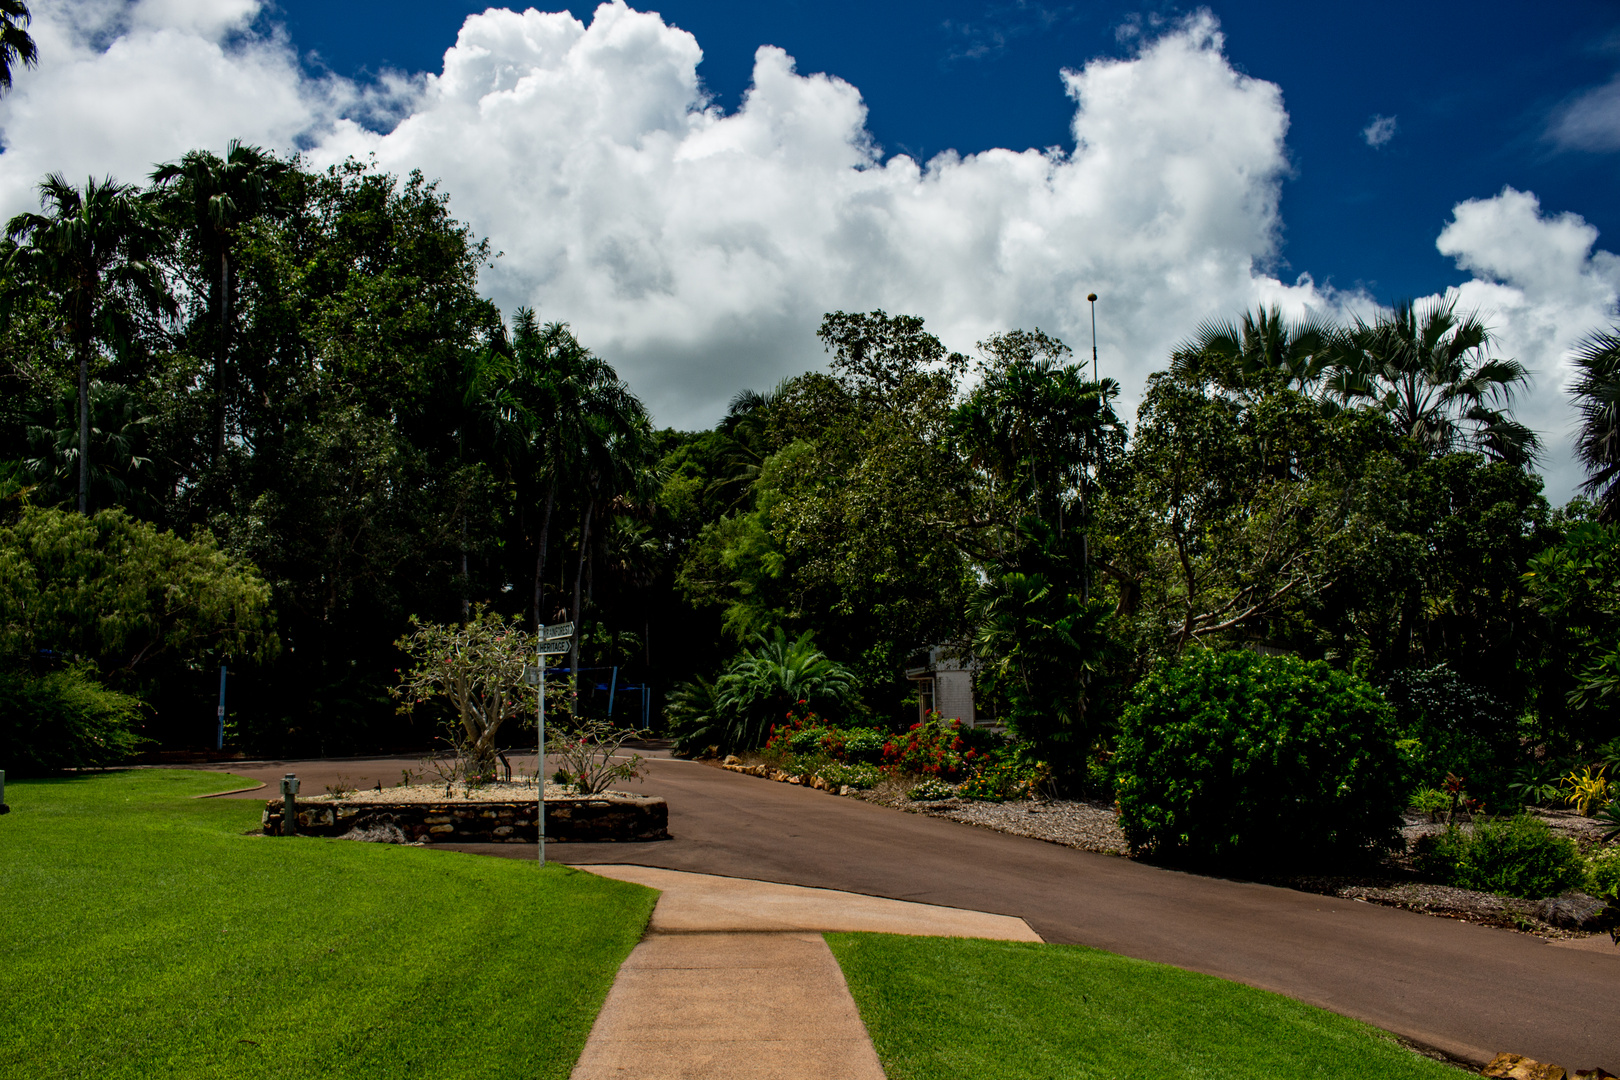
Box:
278;0;1620;303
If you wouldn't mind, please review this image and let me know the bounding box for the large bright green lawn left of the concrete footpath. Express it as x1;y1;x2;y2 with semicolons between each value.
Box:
0;771;656;1080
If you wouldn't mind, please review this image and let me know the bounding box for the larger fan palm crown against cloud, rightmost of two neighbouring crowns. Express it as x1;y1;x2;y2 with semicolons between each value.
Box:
1328;300;1541;465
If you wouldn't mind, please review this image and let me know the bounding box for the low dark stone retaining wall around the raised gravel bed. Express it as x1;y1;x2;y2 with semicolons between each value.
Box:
264;795;669;844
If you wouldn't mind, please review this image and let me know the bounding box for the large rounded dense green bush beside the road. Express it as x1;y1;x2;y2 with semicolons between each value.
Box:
1113;651;1406;866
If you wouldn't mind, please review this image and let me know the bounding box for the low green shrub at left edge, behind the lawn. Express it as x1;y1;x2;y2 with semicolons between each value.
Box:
0;664;143;776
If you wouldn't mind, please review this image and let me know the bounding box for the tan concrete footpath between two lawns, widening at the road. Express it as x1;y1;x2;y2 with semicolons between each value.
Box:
573;865;1040;1080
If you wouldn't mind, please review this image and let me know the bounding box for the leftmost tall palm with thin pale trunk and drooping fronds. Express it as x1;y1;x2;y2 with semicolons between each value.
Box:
6;173;175;513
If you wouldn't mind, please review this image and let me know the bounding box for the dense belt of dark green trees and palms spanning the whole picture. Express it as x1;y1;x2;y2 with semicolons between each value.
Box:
0;139;1620;835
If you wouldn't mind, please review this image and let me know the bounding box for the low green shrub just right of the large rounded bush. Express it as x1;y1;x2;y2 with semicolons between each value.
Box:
1414;814;1586;900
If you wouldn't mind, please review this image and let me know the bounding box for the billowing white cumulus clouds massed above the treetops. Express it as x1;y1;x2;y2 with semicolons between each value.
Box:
0;0;1614;501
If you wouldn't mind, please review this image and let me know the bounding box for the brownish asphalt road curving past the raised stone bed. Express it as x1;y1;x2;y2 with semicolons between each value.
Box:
202;758;1620;1072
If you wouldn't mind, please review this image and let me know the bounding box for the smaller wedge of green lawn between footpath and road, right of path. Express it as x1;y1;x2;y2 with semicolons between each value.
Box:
826;934;1468;1080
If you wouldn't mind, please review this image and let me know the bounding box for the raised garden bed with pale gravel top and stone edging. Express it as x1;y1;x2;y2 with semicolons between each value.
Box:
262;784;669;844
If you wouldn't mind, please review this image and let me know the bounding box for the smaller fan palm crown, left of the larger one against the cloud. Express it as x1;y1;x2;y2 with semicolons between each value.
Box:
1170;304;1338;393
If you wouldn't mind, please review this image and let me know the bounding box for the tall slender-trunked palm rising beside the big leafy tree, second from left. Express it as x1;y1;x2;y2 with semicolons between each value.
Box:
152;139;288;463
